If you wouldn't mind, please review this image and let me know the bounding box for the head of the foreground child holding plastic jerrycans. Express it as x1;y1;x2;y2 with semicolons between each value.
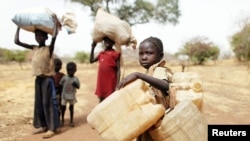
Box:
139;37;164;69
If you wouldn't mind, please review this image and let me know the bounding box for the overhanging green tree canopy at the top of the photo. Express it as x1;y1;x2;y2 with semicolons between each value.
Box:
71;0;180;26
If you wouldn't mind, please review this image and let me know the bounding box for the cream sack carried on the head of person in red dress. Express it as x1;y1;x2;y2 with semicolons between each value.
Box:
92;8;137;51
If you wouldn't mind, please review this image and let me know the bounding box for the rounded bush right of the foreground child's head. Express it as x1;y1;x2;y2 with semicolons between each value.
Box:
178;37;220;65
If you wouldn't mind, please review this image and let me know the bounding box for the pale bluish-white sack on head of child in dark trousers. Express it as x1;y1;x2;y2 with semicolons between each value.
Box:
12;7;77;35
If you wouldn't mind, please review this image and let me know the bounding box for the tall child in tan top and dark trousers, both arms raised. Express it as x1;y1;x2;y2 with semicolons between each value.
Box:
14;16;59;138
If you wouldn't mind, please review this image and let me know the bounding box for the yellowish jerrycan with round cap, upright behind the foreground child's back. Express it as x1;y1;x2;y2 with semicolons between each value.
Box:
170;72;203;110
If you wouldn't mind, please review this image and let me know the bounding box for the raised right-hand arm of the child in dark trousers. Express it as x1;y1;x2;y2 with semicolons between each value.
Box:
50;15;59;57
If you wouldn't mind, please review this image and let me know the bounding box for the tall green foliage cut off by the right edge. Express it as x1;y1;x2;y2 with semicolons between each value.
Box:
230;22;250;61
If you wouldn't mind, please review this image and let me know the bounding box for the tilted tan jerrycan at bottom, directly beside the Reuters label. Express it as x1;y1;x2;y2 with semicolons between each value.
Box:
149;100;208;141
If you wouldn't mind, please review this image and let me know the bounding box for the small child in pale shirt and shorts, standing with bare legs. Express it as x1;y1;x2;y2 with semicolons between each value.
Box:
59;62;80;127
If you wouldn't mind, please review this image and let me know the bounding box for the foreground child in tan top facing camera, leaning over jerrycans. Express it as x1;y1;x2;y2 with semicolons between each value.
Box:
118;37;174;141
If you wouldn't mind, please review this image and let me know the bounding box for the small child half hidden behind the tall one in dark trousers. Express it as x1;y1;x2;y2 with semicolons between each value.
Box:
53;58;64;125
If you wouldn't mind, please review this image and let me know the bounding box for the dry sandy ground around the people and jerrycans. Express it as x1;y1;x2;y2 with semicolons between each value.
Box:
0;61;250;141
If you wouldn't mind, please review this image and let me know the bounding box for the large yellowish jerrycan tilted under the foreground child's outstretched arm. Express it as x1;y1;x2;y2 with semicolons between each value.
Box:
87;79;165;141
